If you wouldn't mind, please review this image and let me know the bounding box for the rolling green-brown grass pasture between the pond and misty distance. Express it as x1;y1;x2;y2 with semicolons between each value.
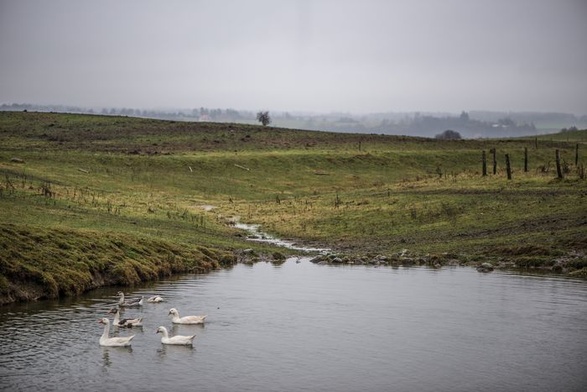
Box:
0;112;587;304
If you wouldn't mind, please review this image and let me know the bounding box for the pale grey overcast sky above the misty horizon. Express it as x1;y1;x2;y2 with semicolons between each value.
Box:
0;0;587;115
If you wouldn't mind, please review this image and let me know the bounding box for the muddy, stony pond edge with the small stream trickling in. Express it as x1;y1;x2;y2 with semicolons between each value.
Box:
0;224;587;306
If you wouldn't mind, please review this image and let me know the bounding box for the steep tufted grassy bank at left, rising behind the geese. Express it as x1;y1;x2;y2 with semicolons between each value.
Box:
0;224;236;303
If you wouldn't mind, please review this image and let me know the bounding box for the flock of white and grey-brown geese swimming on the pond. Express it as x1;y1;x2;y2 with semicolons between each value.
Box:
98;291;206;347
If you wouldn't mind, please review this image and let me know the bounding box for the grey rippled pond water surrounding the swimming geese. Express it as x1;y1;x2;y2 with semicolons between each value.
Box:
0;259;587;392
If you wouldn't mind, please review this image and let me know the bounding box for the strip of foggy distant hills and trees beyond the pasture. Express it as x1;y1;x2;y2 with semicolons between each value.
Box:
0;104;587;138
